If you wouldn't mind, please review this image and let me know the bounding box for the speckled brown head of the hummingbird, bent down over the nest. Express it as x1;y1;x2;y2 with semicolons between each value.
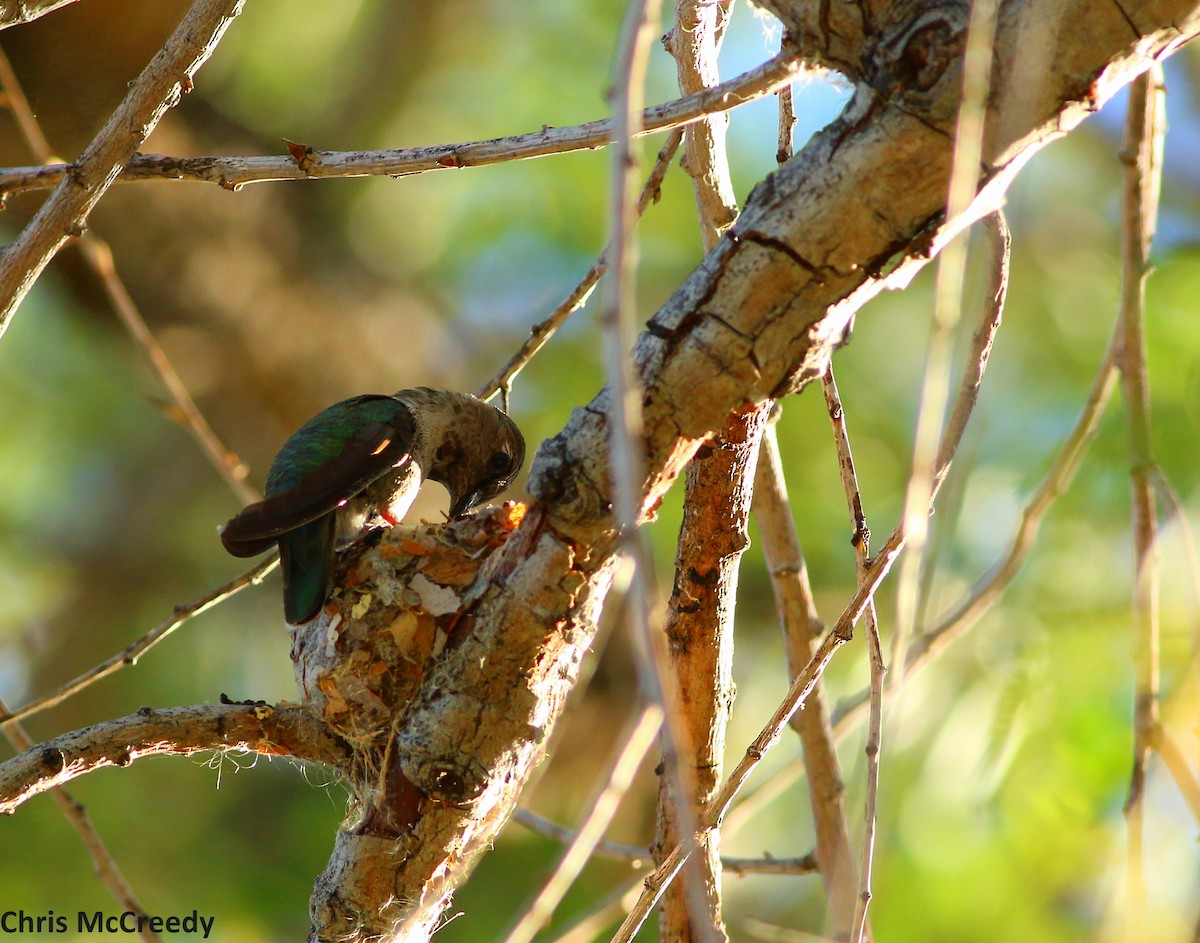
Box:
403;391;524;517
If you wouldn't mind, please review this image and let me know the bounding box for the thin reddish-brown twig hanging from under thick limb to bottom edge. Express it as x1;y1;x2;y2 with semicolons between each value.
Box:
821;361;884;943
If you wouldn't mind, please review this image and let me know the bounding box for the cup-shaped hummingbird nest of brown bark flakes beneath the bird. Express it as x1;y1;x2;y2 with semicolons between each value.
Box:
290;501;526;755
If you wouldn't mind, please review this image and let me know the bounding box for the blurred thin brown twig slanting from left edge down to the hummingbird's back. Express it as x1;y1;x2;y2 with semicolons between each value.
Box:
0;49;259;504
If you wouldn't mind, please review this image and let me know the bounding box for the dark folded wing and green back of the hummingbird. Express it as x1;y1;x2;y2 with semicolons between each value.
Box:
221;396;414;557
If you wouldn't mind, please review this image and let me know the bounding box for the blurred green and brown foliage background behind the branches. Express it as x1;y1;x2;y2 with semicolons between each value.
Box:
0;0;1200;943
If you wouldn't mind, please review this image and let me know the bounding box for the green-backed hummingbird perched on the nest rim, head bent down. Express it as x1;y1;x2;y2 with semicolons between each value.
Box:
221;386;524;625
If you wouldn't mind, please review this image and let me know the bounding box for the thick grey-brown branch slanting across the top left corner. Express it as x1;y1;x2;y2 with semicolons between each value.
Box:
0;0;245;336
